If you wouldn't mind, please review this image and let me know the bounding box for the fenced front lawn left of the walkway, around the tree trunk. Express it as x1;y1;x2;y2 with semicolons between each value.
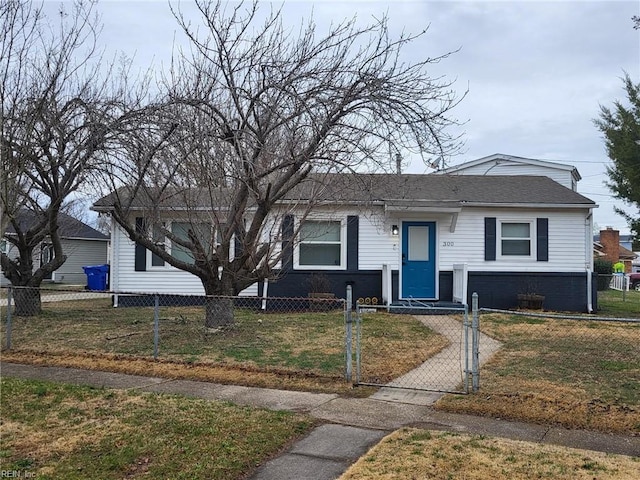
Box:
2;294;446;389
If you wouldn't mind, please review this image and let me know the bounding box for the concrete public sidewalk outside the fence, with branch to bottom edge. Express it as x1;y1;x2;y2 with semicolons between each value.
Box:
0;363;640;480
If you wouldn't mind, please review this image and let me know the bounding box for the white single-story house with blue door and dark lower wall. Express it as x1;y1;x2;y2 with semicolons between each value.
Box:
92;155;596;311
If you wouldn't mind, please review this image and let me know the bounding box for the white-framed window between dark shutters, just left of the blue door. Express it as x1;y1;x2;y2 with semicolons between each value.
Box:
294;219;346;270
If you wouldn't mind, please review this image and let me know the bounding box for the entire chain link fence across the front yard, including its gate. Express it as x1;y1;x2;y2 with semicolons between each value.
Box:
0;287;640;409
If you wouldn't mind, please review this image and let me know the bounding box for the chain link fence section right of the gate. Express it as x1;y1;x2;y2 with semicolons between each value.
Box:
480;308;640;408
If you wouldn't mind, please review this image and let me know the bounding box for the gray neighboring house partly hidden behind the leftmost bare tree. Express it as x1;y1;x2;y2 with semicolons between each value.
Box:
0;211;109;285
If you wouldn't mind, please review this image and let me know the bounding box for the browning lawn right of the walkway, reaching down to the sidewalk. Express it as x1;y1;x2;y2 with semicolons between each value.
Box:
437;315;640;435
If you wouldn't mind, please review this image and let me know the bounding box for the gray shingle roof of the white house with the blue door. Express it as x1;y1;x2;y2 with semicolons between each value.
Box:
93;174;595;210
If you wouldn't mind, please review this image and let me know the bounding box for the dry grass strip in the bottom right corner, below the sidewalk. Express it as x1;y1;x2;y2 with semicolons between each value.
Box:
340;428;640;480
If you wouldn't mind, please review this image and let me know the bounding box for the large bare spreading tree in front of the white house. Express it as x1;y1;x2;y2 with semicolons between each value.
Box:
94;1;459;327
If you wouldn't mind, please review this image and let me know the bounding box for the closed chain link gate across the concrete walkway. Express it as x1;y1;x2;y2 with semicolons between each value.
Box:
351;300;479;393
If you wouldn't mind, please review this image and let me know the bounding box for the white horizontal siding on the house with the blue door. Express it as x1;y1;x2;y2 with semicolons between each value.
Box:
112;203;591;294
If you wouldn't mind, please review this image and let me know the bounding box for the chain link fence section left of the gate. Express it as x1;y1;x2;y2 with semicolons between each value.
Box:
0;287;346;380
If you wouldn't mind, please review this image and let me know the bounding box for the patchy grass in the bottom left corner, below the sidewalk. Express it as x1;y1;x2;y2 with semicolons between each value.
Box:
0;379;315;480
